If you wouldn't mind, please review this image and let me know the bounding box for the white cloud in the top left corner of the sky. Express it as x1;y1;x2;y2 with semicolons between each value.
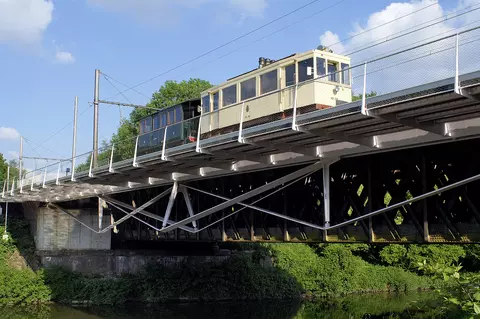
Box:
0;0;54;45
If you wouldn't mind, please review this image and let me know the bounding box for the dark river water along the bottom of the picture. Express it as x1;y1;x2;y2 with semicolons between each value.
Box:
0;292;462;319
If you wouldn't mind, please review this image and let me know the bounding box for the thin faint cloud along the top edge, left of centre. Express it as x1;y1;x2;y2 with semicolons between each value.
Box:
87;0;267;25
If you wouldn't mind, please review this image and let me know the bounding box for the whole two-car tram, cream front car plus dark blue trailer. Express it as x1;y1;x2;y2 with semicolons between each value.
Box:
137;46;352;155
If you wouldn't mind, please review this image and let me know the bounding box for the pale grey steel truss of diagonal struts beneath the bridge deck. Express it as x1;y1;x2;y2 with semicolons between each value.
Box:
49;162;480;240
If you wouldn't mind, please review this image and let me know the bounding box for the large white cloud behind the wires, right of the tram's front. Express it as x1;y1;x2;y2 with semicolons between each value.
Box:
320;0;480;93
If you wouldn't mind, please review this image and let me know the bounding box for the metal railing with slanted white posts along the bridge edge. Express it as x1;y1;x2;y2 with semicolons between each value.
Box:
0;27;480;196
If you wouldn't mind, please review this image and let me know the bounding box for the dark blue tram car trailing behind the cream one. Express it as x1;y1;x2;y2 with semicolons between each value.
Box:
137;99;201;155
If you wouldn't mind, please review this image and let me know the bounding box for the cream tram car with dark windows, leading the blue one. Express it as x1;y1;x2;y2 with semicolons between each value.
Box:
201;47;352;135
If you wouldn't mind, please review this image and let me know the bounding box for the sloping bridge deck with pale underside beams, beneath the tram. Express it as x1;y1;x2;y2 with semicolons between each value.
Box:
0;72;480;202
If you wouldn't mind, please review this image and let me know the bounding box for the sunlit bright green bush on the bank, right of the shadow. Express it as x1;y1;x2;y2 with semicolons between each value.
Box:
267;244;431;296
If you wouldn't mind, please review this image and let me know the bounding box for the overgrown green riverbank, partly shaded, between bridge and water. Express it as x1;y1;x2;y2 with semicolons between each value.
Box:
0;216;476;304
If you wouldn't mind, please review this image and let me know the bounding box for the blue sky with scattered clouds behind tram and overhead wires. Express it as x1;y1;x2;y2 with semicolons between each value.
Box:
0;0;480;175
